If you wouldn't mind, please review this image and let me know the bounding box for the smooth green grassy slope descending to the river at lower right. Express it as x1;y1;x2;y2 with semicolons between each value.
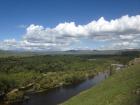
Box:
63;65;140;105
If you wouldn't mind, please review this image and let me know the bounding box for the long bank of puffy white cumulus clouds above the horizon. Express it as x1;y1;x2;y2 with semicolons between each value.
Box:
0;15;140;50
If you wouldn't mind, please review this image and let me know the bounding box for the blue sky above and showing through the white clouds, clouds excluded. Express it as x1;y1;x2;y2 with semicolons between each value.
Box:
0;0;140;49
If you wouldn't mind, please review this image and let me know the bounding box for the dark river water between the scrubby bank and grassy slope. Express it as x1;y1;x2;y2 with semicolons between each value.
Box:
14;72;109;105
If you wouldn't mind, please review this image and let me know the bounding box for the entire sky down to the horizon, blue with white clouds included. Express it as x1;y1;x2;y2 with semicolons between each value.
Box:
0;0;140;51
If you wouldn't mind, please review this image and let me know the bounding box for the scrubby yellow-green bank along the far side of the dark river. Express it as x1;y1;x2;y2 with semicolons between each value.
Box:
0;70;96;104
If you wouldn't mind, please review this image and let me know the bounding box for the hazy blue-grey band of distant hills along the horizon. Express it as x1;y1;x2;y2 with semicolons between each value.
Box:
0;49;140;57
